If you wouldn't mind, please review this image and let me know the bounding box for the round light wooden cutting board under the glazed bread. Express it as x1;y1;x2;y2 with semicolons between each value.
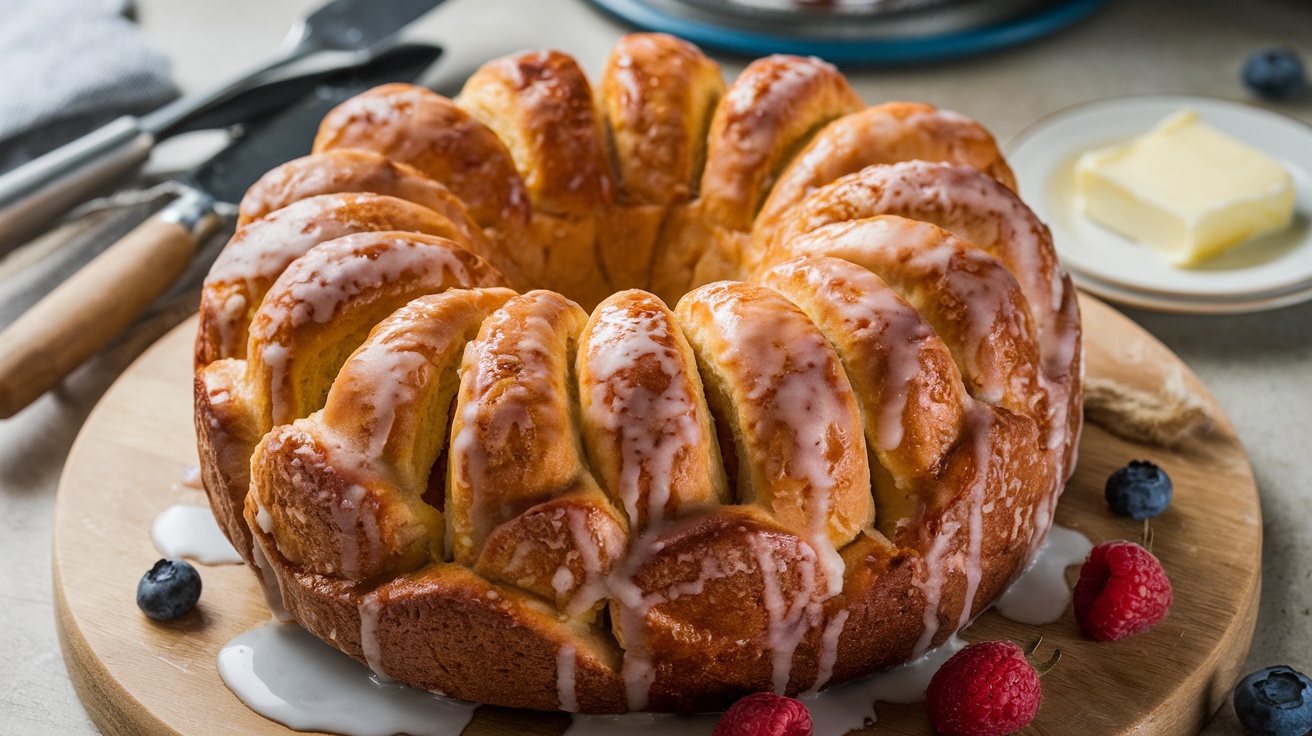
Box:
54;298;1262;736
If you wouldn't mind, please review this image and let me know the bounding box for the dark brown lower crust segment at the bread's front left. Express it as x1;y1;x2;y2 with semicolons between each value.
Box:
256;545;625;712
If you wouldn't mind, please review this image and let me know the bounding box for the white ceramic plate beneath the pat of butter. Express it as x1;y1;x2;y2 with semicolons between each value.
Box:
1006;96;1312;314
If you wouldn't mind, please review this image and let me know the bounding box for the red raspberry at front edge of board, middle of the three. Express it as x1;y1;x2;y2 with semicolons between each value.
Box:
925;642;1043;736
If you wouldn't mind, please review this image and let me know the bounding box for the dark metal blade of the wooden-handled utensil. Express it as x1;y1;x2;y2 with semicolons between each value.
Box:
180;45;441;203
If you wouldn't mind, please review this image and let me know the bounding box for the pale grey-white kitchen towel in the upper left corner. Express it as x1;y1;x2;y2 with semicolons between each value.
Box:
0;0;177;172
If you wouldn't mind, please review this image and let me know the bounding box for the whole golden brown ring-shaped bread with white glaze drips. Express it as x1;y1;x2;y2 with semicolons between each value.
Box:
195;34;1082;712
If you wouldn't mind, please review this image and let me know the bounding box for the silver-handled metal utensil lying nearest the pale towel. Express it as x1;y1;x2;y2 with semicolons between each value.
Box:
0;0;445;253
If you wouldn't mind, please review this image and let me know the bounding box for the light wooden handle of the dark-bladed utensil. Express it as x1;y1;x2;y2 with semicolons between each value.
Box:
0;215;195;417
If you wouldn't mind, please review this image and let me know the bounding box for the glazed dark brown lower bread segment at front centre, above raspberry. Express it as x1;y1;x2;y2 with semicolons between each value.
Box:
610;504;844;712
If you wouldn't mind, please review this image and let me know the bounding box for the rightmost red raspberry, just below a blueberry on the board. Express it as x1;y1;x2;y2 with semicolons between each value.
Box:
1075;541;1172;642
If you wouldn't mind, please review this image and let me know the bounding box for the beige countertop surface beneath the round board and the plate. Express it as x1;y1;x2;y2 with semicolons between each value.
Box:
0;0;1312;735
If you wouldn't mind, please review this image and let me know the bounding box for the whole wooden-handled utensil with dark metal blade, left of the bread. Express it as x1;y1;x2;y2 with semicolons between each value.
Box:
0;45;441;417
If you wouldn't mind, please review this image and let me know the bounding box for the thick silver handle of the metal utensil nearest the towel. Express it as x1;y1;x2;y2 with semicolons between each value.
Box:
0;115;155;253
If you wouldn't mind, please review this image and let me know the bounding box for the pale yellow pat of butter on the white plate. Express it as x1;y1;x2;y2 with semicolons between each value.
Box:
1076;110;1294;266
